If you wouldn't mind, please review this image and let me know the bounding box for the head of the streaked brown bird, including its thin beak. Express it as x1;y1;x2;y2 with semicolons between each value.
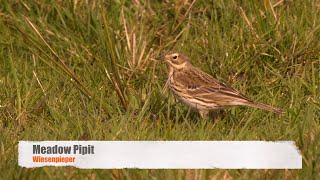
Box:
156;52;189;69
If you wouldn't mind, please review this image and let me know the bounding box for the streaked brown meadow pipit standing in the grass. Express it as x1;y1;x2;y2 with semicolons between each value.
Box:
155;51;284;119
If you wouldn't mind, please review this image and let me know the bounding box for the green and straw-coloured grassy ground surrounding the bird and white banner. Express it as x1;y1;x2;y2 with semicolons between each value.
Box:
0;0;320;179
